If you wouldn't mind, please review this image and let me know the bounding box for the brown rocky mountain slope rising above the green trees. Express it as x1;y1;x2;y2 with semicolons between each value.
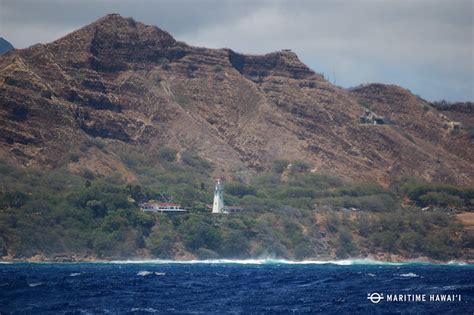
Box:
0;15;474;184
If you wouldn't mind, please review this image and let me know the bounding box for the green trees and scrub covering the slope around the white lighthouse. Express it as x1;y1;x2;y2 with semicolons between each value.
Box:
0;154;474;260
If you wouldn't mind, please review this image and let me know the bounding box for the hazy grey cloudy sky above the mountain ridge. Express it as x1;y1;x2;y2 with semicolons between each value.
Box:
0;0;474;101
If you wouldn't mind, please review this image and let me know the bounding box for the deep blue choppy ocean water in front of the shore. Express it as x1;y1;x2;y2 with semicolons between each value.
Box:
0;261;474;314
